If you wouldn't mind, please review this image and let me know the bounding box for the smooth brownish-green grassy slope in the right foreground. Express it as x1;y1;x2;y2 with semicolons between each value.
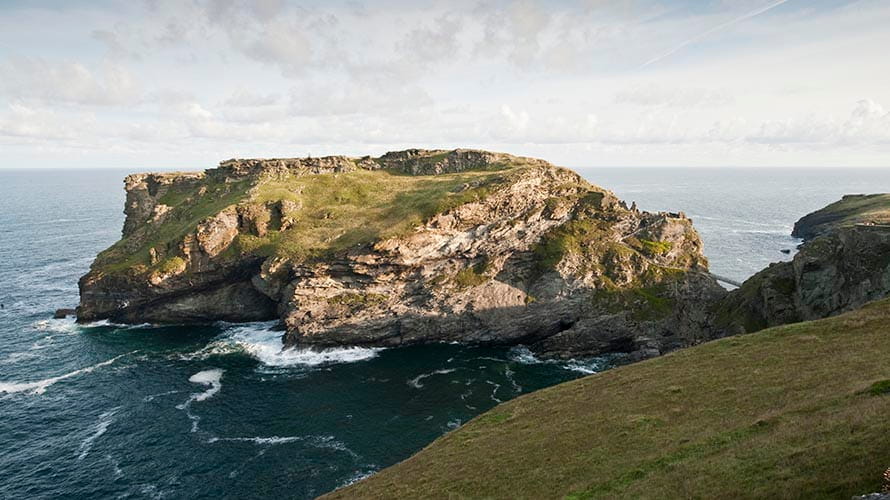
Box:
330;300;890;498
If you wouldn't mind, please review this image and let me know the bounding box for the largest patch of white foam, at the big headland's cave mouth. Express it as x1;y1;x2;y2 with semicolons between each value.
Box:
180;321;383;367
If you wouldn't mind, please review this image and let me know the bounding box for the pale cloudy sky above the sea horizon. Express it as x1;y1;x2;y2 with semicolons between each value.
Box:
0;0;890;168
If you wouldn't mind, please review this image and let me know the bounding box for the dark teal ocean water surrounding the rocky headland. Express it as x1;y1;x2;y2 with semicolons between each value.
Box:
0;168;890;498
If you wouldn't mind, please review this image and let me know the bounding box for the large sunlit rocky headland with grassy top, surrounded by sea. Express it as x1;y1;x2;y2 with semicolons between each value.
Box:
78;150;723;357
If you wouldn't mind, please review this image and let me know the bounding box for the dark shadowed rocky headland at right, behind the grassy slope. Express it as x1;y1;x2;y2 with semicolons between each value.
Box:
717;195;890;333
